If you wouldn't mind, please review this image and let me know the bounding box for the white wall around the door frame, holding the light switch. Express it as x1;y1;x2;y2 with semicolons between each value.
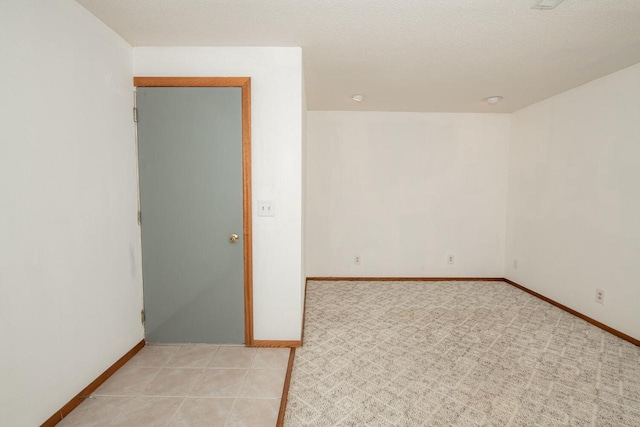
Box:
133;47;303;340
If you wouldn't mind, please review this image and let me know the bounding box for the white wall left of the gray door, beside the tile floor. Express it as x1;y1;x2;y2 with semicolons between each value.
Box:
0;0;143;426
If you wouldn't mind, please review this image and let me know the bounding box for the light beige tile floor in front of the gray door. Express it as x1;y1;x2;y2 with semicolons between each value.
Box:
58;344;290;427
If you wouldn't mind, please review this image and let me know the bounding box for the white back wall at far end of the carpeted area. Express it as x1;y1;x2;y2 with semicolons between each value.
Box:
307;111;510;277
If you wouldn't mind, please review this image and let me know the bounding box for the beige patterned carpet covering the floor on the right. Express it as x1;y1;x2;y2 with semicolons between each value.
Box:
284;282;640;427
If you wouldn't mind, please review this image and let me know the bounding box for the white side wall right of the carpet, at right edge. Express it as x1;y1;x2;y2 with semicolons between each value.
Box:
506;64;640;338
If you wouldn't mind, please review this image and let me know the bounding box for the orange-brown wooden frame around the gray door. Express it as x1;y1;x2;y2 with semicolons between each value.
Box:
133;77;254;347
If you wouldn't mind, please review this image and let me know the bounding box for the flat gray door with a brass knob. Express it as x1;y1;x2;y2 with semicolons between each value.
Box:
137;87;244;344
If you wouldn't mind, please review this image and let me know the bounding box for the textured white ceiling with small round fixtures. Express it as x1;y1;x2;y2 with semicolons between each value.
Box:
77;0;640;112
